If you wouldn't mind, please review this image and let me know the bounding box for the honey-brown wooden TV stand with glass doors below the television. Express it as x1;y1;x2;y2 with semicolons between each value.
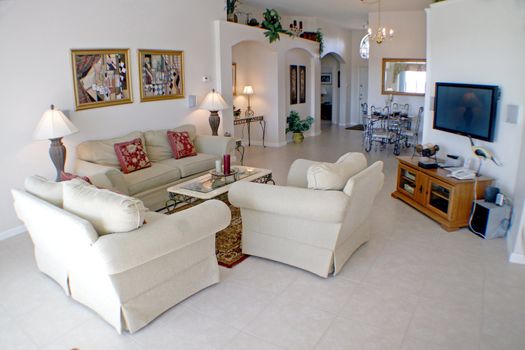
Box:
392;157;493;232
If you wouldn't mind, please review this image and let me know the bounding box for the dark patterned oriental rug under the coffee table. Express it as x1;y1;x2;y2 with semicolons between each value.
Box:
170;198;248;269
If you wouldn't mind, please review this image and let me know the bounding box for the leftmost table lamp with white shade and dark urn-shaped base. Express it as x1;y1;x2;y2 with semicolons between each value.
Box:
33;105;78;181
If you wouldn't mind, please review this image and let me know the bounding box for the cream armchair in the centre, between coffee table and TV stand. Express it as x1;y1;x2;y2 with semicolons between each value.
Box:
229;153;384;277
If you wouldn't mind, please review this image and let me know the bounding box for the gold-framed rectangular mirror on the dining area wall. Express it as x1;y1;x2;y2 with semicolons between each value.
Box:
381;58;427;96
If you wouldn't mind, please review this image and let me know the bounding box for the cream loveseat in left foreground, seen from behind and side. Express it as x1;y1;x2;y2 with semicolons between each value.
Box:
12;177;230;333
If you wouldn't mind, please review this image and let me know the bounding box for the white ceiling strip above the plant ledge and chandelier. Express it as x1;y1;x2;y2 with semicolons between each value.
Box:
243;0;433;29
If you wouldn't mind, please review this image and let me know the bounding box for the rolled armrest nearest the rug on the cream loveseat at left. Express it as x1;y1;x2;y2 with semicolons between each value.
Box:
93;200;231;275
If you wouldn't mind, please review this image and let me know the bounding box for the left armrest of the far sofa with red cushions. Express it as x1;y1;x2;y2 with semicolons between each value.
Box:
75;159;129;194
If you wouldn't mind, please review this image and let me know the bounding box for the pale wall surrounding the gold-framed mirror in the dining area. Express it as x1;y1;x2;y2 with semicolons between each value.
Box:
368;11;428;114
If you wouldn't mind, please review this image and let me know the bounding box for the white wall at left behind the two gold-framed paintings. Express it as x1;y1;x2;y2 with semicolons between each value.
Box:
0;0;225;232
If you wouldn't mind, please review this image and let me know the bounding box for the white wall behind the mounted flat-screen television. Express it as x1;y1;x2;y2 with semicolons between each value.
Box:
423;0;525;260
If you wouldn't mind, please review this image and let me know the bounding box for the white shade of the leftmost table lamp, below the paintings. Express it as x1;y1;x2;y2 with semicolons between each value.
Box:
33;105;78;140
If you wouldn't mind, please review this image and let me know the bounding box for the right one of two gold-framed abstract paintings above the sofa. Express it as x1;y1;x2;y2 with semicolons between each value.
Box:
138;50;184;102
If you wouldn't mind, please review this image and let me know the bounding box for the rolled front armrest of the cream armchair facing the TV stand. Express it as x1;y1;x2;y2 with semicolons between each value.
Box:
228;181;348;223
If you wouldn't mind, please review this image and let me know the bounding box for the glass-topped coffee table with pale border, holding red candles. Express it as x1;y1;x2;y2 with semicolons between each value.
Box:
166;166;275;212
